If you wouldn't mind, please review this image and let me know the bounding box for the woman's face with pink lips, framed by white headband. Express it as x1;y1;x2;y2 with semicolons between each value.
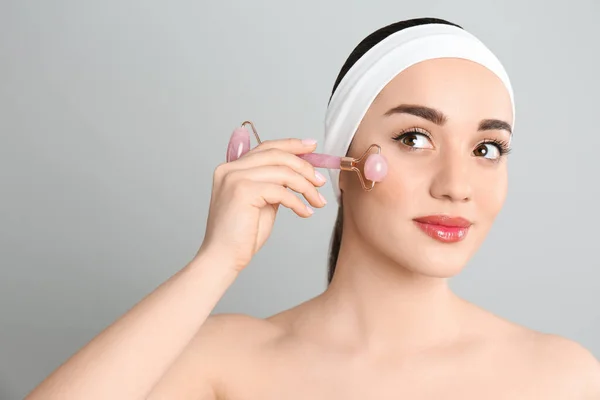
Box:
340;59;513;277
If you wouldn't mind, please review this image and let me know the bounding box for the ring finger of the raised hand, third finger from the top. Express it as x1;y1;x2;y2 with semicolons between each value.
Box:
231;165;327;208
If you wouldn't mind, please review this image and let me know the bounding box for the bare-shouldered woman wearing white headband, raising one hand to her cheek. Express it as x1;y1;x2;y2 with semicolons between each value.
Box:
28;19;600;400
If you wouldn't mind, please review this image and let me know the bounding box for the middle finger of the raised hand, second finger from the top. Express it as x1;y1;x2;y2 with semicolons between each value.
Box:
223;148;327;187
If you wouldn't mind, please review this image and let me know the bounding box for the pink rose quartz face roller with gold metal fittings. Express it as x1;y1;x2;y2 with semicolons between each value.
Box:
227;121;387;191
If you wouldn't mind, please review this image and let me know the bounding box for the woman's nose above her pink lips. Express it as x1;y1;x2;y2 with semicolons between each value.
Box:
430;154;473;202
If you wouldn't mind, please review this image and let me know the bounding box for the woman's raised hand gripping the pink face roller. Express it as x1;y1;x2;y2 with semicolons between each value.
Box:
200;139;326;271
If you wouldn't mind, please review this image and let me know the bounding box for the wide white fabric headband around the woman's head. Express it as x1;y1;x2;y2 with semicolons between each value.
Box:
324;24;515;202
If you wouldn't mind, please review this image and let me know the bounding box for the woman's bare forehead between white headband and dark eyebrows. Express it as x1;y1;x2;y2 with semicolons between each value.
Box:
369;58;513;124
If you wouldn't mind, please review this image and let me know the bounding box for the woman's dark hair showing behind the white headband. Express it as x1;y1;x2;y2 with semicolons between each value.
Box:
327;18;462;284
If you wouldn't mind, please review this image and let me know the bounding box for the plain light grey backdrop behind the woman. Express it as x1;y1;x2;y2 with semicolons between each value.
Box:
0;0;600;399
